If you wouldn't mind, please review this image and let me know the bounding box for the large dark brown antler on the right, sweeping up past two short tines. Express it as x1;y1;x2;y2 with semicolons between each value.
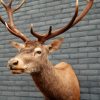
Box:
30;0;94;43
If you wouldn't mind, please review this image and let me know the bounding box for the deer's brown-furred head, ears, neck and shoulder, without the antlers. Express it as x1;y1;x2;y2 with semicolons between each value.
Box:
8;39;80;100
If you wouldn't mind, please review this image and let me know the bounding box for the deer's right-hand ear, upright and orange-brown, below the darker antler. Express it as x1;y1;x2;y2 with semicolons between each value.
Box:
48;38;64;53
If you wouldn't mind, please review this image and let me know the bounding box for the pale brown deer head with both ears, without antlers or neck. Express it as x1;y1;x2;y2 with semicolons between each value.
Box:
8;39;63;74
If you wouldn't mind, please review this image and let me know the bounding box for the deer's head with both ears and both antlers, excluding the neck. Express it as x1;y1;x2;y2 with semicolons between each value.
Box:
0;0;94;74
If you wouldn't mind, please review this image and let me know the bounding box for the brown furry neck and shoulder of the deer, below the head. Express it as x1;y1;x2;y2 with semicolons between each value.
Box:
32;62;80;100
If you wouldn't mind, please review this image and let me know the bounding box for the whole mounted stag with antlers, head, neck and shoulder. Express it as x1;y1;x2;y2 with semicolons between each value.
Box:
0;0;94;100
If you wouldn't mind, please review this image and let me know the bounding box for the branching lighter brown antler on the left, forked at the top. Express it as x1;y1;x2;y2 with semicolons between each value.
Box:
0;0;29;42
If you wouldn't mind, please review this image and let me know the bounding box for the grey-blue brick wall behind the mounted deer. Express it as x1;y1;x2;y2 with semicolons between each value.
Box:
0;0;100;100
